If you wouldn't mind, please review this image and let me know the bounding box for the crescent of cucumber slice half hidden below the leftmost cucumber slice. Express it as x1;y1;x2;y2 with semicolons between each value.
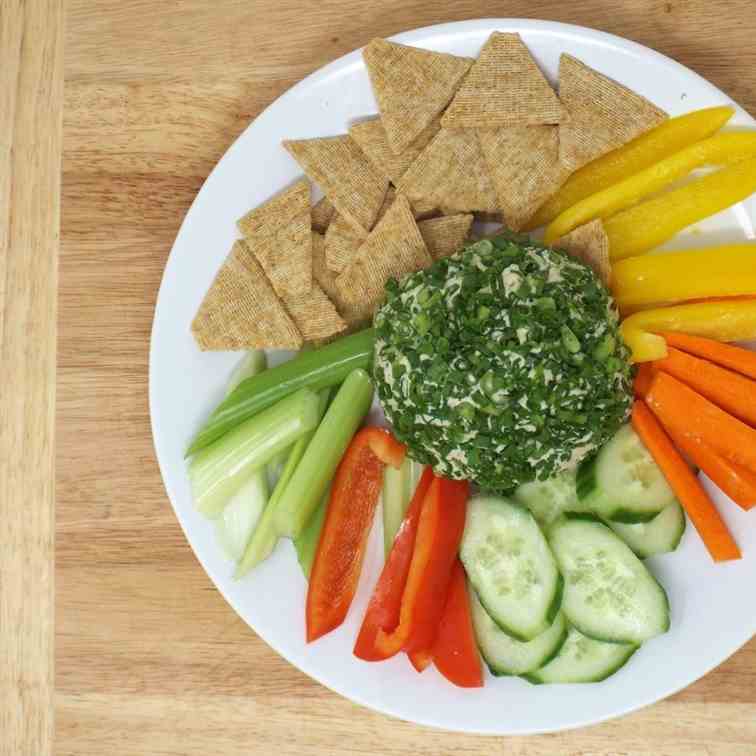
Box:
470;591;567;677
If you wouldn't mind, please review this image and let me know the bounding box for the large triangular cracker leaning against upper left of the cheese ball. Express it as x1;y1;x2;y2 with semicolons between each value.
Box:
336;195;433;317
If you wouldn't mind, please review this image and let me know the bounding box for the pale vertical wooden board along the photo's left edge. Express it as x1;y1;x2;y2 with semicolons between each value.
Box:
0;0;63;756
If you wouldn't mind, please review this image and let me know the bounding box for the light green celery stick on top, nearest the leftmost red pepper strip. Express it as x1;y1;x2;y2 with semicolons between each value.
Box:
276;370;373;538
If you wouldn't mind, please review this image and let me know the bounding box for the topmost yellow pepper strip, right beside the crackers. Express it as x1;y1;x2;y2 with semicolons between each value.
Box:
523;105;735;231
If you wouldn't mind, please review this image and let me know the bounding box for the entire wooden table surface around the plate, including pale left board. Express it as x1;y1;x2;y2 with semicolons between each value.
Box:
26;0;756;756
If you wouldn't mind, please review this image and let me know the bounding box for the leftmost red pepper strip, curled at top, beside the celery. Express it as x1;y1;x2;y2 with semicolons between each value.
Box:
306;427;406;643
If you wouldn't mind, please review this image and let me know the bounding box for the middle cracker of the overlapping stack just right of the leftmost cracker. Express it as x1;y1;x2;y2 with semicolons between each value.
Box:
246;213;312;297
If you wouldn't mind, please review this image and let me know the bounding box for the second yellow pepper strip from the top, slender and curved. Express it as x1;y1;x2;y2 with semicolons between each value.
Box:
544;131;756;244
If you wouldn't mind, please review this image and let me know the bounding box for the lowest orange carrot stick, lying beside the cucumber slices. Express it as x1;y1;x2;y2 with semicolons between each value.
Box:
632;400;740;562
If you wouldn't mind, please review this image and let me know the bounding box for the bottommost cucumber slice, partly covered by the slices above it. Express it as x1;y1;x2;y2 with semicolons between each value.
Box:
523;627;638;684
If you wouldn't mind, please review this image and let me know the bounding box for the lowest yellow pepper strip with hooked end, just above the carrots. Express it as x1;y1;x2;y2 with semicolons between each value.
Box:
621;298;756;362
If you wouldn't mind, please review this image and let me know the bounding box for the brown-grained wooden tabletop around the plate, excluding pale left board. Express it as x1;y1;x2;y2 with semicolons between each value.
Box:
59;0;756;756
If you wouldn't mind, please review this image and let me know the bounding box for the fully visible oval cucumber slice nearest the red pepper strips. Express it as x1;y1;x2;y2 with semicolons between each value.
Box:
460;496;562;641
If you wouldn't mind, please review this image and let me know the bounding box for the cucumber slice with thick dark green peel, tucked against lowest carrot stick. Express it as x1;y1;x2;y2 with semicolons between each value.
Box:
576;425;675;523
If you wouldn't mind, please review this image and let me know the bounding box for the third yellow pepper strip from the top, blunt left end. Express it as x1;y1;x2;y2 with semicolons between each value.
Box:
604;158;756;261
